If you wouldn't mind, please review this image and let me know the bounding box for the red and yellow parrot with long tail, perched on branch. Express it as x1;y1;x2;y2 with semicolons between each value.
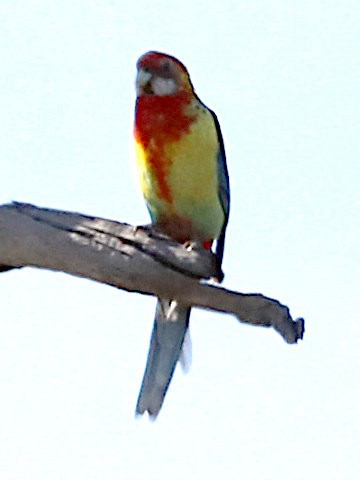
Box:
134;52;230;418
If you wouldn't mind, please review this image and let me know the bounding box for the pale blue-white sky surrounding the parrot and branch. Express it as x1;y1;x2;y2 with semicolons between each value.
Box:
0;0;360;480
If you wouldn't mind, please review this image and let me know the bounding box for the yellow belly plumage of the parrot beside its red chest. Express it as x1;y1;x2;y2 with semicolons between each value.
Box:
136;106;225;240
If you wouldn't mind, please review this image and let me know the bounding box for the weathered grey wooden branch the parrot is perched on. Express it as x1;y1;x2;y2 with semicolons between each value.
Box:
0;203;304;343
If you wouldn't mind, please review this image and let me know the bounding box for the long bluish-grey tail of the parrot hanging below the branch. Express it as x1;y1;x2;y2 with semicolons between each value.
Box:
136;299;190;418
